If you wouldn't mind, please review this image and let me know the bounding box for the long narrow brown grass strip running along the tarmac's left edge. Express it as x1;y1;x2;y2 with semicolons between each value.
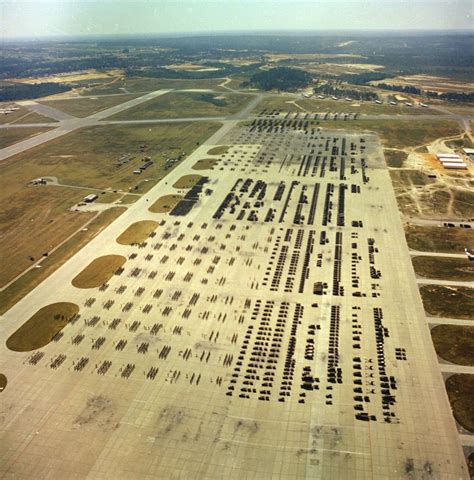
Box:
0;207;126;315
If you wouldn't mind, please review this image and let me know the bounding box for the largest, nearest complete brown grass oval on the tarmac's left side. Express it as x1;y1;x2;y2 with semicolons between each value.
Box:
6;302;79;352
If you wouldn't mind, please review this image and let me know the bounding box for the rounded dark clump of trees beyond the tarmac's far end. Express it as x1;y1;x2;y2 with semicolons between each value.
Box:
242;67;312;92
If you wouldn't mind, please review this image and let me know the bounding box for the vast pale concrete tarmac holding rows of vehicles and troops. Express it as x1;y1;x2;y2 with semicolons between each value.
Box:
0;120;468;479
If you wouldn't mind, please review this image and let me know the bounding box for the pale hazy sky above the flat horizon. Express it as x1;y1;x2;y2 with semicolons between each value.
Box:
0;0;473;38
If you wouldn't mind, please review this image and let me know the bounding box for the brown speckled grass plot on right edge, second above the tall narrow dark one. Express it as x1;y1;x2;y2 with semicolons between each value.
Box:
420;285;474;320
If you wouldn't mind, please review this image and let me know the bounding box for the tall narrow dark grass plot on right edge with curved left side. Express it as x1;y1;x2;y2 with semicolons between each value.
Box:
446;374;474;432
